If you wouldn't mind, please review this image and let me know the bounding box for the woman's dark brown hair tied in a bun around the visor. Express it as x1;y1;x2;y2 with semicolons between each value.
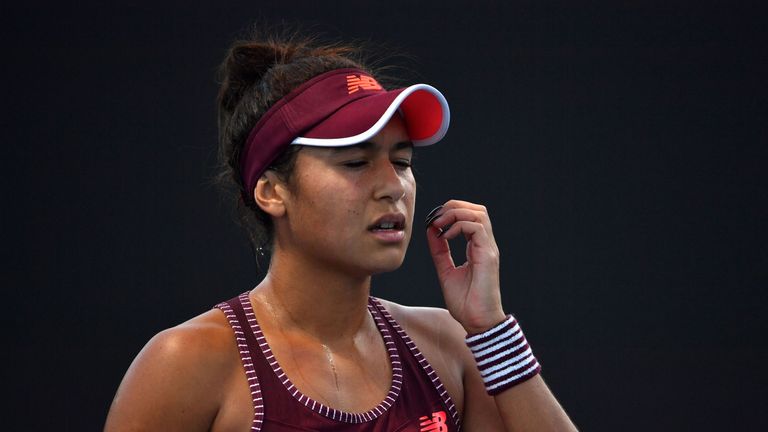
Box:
217;29;372;252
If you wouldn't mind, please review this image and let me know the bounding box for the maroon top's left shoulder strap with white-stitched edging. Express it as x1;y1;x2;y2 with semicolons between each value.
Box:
216;291;264;432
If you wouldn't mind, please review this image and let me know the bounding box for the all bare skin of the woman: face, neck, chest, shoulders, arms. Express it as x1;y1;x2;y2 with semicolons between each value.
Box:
105;116;576;432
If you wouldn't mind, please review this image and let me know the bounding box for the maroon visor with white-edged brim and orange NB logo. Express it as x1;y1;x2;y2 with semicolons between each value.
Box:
240;69;451;195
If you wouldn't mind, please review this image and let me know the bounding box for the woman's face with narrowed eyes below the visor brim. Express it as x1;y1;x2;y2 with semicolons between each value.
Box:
276;115;416;275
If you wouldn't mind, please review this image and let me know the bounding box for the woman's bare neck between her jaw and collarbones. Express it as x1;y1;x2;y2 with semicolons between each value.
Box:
253;248;371;344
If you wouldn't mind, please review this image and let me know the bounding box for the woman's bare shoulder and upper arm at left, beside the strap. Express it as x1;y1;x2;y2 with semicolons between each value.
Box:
105;309;239;431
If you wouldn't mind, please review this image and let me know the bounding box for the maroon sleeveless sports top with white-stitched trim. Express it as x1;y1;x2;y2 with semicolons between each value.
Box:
216;292;460;432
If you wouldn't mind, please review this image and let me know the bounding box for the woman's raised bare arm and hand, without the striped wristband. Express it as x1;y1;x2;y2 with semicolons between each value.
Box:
427;200;576;431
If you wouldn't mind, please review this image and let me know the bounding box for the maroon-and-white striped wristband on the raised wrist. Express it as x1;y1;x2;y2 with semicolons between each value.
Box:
466;315;541;396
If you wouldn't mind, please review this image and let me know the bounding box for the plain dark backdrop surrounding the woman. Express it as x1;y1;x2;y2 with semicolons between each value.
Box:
0;1;768;431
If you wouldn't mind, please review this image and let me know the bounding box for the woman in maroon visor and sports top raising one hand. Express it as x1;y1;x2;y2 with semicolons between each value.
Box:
105;31;575;431
